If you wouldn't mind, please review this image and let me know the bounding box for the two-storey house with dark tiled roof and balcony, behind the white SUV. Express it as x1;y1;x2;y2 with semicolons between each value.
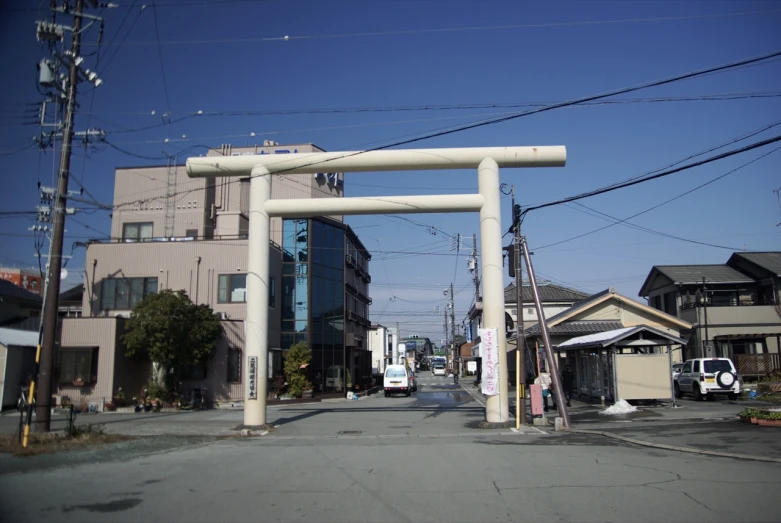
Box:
640;252;781;377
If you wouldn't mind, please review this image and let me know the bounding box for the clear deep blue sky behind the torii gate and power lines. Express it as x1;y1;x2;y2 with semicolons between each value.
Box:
0;0;781;342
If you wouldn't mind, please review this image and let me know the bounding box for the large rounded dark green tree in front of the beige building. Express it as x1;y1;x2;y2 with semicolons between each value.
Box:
122;290;222;391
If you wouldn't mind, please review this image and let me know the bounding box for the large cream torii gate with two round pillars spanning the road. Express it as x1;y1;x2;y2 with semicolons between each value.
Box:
187;146;567;427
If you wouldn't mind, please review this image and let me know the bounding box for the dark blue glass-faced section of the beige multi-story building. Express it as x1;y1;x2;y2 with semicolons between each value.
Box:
281;218;371;394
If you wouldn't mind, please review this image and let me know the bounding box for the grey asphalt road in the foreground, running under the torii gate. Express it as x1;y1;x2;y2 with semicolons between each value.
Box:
0;376;781;523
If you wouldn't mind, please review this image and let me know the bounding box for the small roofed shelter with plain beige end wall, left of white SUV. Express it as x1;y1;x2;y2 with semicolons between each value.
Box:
554;325;687;404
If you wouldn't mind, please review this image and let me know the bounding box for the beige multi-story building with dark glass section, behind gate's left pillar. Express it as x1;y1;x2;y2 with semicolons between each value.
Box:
57;143;371;410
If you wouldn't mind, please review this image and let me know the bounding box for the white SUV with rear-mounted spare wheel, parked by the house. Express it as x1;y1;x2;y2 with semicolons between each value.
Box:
675;358;740;400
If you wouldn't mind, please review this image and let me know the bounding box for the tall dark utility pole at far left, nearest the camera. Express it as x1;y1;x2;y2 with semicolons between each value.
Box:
34;0;99;432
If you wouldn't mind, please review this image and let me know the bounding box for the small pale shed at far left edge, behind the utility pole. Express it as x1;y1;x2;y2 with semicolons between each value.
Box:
0;327;38;410
